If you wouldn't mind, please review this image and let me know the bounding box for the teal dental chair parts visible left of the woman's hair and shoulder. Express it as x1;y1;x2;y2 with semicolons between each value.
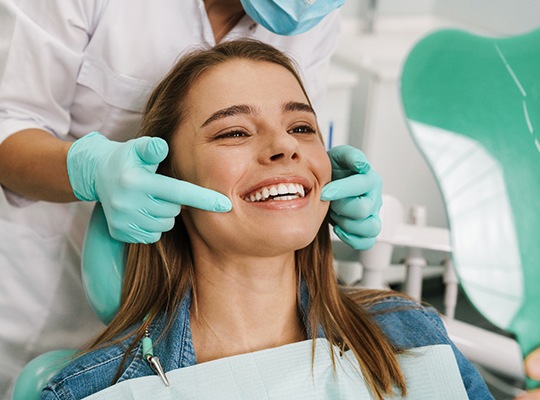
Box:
13;203;125;400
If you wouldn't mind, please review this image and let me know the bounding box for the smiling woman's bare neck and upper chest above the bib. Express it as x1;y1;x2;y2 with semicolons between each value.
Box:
191;253;305;363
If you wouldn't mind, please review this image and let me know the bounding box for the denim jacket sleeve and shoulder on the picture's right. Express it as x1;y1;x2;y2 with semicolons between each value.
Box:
369;298;493;400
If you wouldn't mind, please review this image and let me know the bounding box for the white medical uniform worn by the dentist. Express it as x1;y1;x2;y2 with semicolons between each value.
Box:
0;0;338;398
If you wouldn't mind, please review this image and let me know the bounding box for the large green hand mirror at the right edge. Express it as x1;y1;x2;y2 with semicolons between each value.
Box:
401;26;540;389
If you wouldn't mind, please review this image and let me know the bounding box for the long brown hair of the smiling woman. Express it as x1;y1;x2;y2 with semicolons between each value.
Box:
85;40;406;399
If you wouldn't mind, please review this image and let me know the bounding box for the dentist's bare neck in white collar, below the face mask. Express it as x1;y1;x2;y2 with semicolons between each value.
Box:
204;0;245;43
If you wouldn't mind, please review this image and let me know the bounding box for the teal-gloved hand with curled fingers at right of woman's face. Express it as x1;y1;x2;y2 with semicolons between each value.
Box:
321;145;382;250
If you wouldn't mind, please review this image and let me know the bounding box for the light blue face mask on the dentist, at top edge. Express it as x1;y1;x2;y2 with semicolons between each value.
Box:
241;0;345;36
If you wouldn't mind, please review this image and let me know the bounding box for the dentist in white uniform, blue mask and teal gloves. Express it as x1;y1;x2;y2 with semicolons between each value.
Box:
0;0;381;398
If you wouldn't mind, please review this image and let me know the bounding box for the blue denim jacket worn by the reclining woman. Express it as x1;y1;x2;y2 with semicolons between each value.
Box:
40;290;493;400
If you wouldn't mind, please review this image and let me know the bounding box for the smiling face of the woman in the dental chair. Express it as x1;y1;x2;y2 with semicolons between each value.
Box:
172;59;331;256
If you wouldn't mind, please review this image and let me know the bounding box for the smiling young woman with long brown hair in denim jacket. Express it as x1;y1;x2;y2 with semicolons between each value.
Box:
42;41;491;399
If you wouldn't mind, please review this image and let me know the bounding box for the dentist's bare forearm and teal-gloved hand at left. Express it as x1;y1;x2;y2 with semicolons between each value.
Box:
0;131;231;243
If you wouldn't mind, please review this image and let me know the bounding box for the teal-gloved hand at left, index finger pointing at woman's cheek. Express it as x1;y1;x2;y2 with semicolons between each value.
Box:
67;132;232;243
